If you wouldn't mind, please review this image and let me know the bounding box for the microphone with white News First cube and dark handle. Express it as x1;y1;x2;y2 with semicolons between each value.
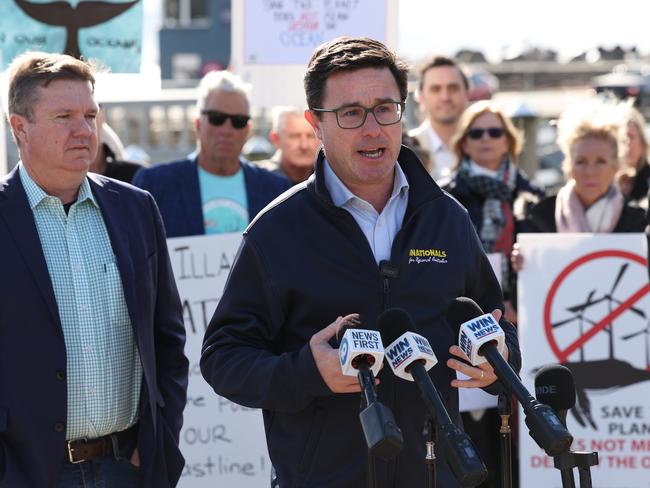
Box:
336;315;404;461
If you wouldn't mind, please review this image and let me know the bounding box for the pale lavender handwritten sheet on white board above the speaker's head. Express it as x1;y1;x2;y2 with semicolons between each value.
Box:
243;0;388;65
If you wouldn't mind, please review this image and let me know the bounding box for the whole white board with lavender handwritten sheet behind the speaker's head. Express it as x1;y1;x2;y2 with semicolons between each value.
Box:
230;0;398;107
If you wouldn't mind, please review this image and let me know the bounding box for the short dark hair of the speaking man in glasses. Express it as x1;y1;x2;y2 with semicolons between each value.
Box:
304;36;409;108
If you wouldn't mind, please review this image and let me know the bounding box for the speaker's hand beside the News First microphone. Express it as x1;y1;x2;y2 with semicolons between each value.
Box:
309;316;361;393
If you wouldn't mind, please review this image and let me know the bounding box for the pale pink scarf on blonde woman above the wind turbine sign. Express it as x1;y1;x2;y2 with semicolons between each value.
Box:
555;180;623;233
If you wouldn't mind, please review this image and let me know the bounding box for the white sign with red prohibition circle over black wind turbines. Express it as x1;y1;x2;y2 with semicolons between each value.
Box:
518;234;650;488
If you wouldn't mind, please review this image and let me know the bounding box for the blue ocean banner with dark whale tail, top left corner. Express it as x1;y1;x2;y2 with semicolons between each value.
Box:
0;0;143;73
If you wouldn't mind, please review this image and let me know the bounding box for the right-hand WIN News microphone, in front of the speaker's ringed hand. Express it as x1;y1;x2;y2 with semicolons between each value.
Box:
447;297;573;456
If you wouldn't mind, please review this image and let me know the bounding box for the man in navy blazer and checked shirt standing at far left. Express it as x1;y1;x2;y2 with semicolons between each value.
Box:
0;53;188;488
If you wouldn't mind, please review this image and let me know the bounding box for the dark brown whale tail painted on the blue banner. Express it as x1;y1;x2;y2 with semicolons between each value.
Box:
14;0;140;58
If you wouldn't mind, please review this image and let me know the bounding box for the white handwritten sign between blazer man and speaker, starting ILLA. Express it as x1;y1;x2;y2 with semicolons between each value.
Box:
167;234;271;488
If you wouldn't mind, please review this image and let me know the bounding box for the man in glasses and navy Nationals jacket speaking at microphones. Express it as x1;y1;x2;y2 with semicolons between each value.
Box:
201;37;519;488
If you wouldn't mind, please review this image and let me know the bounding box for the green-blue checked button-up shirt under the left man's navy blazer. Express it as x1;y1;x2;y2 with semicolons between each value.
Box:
19;163;142;439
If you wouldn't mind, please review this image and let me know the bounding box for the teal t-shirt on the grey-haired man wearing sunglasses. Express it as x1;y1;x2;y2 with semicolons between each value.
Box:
198;166;249;234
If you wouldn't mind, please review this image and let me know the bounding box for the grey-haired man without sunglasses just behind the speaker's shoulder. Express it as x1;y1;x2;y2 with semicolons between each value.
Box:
259;106;320;184
